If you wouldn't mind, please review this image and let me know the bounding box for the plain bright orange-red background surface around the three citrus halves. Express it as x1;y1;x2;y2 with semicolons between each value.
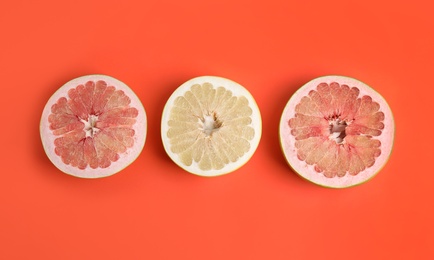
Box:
0;0;434;259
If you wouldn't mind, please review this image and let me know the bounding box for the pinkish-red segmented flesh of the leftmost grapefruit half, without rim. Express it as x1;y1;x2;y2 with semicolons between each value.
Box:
48;80;138;169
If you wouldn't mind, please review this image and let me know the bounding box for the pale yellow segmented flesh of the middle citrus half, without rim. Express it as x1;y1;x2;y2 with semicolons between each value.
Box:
166;83;255;171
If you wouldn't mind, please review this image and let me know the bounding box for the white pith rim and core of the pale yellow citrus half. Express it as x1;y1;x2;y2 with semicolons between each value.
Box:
161;76;262;177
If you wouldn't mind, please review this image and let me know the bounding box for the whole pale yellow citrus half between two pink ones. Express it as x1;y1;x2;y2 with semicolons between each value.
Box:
161;76;262;176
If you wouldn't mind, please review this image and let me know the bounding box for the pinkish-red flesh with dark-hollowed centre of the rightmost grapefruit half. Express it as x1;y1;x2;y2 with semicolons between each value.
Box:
288;82;385;178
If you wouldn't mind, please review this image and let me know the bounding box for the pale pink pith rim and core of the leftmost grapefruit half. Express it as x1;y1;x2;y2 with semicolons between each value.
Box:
40;75;147;178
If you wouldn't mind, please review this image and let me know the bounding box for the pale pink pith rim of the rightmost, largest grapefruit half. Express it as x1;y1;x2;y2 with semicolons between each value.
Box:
279;76;395;188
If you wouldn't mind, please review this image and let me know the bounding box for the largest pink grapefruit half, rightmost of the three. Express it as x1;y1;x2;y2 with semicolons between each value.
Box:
280;76;395;188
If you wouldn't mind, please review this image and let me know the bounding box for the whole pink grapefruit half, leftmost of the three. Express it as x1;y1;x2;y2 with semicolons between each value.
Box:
40;75;147;178
